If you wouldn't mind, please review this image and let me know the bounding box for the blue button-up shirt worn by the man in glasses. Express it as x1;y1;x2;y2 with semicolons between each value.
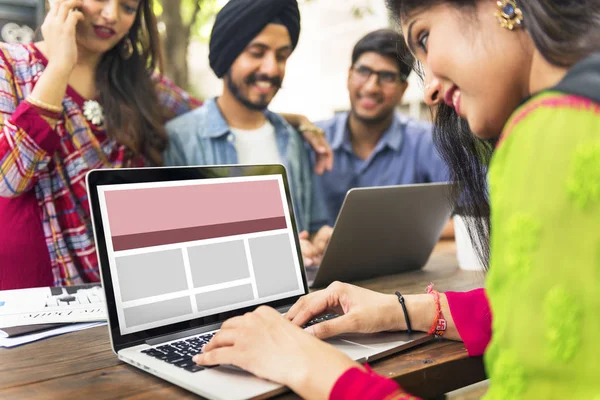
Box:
317;112;449;224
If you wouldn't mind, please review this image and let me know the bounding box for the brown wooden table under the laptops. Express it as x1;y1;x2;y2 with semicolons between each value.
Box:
0;242;485;399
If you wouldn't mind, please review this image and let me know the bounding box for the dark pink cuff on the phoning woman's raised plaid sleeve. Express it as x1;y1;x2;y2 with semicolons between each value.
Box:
11;101;60;156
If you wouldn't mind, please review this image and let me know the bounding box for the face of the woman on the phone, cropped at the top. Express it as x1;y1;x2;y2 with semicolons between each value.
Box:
77;0;139;54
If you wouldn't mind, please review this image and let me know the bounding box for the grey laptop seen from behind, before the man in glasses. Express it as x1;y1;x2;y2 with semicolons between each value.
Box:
307;183;453;288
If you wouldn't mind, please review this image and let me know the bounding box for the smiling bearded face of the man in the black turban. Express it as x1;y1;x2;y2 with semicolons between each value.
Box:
225;24;292;110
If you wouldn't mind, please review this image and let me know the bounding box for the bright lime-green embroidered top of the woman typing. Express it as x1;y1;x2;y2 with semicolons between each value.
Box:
485;92;600;400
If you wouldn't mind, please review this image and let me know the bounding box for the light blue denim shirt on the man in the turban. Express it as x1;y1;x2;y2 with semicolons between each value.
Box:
164;99;327;232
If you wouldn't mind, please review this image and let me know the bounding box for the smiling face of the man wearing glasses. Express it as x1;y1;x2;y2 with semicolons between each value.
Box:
348;52;407;123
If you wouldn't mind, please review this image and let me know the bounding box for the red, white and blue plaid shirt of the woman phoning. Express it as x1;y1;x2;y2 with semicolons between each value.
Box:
0;43;200;285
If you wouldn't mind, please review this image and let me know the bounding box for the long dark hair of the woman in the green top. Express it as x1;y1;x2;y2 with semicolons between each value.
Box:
386;0;600;266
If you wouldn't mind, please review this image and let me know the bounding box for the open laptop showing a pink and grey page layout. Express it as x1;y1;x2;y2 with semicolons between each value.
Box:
87;165;430;399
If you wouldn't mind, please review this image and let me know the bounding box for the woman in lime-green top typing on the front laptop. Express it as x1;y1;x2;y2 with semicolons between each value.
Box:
195;0;600;399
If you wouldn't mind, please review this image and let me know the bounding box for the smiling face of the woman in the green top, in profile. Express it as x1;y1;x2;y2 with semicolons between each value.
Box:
402;0;533;139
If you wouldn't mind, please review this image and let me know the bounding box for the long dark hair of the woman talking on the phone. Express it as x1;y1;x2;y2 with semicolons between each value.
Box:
96;0;167;165
